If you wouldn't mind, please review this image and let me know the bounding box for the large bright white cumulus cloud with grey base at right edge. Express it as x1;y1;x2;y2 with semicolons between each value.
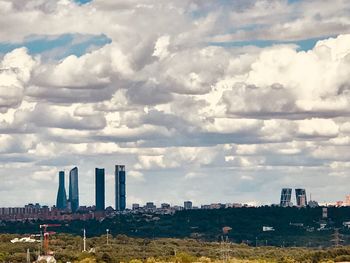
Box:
221;35;350;118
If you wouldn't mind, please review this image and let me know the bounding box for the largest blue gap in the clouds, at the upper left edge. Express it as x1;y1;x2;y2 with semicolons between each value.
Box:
0;34;111;59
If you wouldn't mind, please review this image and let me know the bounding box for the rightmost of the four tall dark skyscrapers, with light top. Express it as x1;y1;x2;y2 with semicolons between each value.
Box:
115;165;126;211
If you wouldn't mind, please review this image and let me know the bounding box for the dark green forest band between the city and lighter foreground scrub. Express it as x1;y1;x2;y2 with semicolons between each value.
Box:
0;207;350;247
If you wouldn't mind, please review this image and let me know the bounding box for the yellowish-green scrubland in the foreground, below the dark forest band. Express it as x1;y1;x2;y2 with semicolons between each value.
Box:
0;234;350;263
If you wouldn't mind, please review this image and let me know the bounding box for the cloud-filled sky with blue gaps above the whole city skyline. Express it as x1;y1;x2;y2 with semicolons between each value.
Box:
0;0;350;207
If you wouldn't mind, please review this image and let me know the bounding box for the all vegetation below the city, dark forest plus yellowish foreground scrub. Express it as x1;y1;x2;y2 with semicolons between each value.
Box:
0;207;350;263
